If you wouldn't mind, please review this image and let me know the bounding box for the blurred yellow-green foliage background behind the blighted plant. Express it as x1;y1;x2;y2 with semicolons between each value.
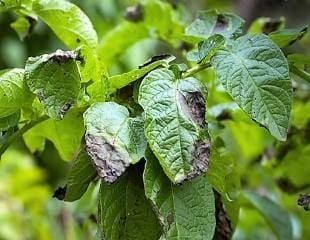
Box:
0;0;310;240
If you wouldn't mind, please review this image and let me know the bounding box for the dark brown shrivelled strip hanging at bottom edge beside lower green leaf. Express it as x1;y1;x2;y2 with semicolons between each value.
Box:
213;191;233;240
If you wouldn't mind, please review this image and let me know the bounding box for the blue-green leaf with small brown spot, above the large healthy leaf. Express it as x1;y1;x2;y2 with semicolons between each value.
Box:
185;10;244;39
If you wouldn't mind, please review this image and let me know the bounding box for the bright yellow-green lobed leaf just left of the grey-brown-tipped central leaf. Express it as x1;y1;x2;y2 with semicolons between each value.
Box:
23;111;84;161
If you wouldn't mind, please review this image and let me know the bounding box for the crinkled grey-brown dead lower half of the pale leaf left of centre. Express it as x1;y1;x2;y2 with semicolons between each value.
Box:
85;133;129;183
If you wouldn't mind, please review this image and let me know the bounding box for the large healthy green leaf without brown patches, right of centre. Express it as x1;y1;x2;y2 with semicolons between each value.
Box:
211;35;292;141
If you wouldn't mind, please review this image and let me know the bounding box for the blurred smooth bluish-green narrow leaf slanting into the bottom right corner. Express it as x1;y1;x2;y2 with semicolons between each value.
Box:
244;192;294;240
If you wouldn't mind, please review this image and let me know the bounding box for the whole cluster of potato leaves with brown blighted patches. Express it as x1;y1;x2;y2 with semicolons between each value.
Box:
0;0;309;240
